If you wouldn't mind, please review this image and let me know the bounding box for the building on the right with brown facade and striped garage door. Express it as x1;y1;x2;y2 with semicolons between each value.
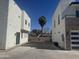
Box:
52;0;79;49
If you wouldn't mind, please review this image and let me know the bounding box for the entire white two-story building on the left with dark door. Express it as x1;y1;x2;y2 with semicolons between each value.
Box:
0;0;30;49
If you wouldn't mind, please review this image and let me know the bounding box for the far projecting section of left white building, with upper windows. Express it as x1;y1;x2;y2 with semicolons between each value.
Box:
20;11;31;43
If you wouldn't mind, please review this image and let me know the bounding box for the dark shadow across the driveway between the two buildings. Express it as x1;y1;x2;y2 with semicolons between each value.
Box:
22;42;62;50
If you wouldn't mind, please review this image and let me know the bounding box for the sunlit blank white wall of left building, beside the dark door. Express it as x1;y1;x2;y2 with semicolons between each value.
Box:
5;0;22;49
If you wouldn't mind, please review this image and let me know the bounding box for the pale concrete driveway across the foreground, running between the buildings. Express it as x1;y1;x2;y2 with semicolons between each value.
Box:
0;43;79;59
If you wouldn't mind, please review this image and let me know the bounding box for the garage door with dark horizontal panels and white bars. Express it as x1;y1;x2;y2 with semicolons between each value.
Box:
70;30;79;49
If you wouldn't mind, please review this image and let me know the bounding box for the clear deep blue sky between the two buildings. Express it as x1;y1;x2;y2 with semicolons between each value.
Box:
16;0;59;30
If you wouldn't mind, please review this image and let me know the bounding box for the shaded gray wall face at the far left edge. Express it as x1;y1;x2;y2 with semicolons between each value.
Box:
0;0;8;49
